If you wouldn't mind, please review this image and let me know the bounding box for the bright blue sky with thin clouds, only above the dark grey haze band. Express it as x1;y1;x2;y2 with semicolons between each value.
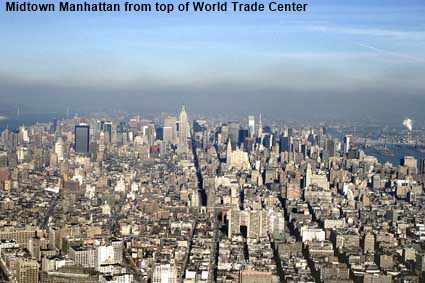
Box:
0;0;425;119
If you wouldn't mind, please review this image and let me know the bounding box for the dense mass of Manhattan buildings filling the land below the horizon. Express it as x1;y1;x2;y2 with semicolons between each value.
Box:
0;107;425;283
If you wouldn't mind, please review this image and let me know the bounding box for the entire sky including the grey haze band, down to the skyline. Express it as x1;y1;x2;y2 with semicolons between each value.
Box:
0;0;425;121
